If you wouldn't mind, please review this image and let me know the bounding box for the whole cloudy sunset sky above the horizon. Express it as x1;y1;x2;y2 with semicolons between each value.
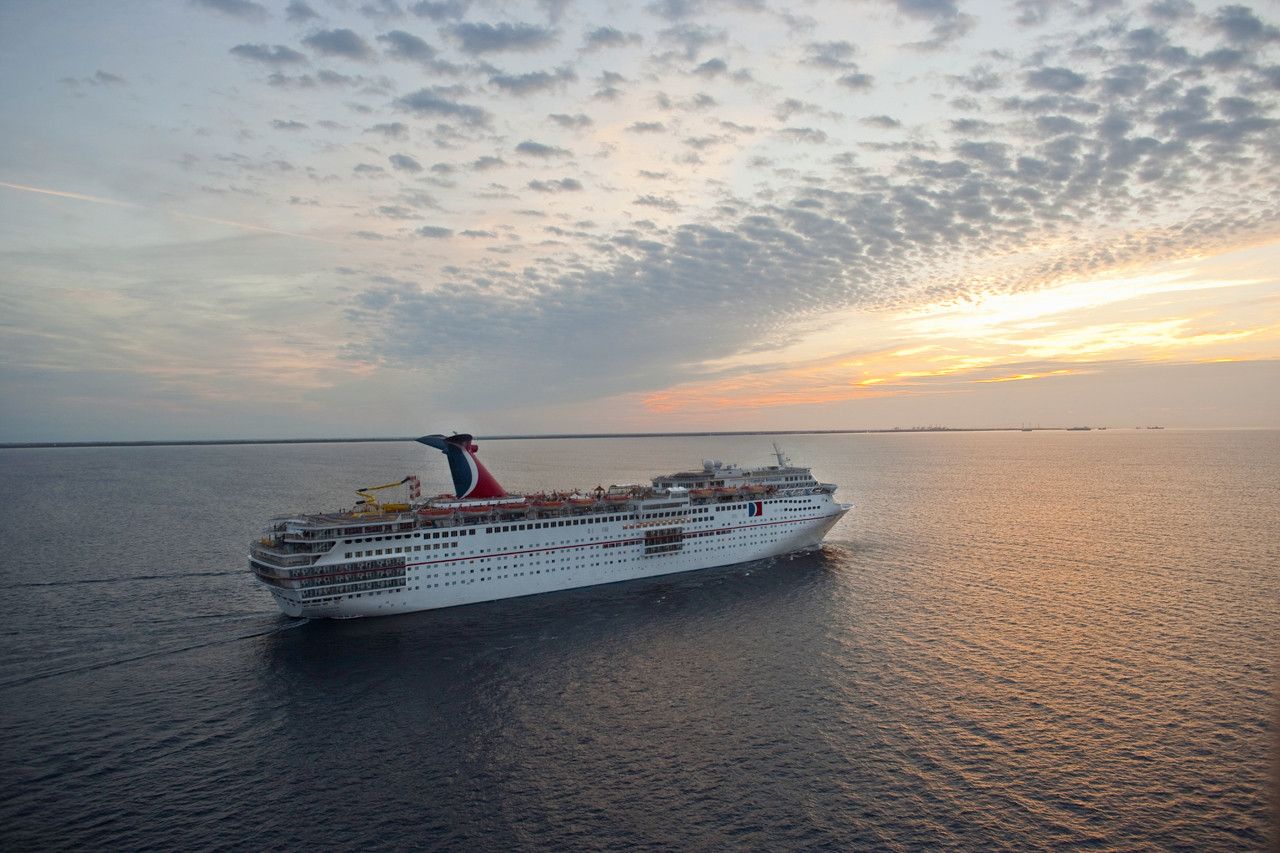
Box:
0;0;1280;442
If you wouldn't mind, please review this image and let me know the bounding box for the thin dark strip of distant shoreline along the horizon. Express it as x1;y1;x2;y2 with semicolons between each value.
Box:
0;427;1164;450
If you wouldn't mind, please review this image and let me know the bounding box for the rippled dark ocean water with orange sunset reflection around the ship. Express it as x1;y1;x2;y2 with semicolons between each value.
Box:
0;429;1280;852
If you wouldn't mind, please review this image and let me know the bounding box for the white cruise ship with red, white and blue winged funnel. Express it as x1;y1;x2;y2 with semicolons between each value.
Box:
250;434;850;619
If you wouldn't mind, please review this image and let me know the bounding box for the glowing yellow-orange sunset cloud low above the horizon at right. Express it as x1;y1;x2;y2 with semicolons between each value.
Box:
643;265;1280;414
